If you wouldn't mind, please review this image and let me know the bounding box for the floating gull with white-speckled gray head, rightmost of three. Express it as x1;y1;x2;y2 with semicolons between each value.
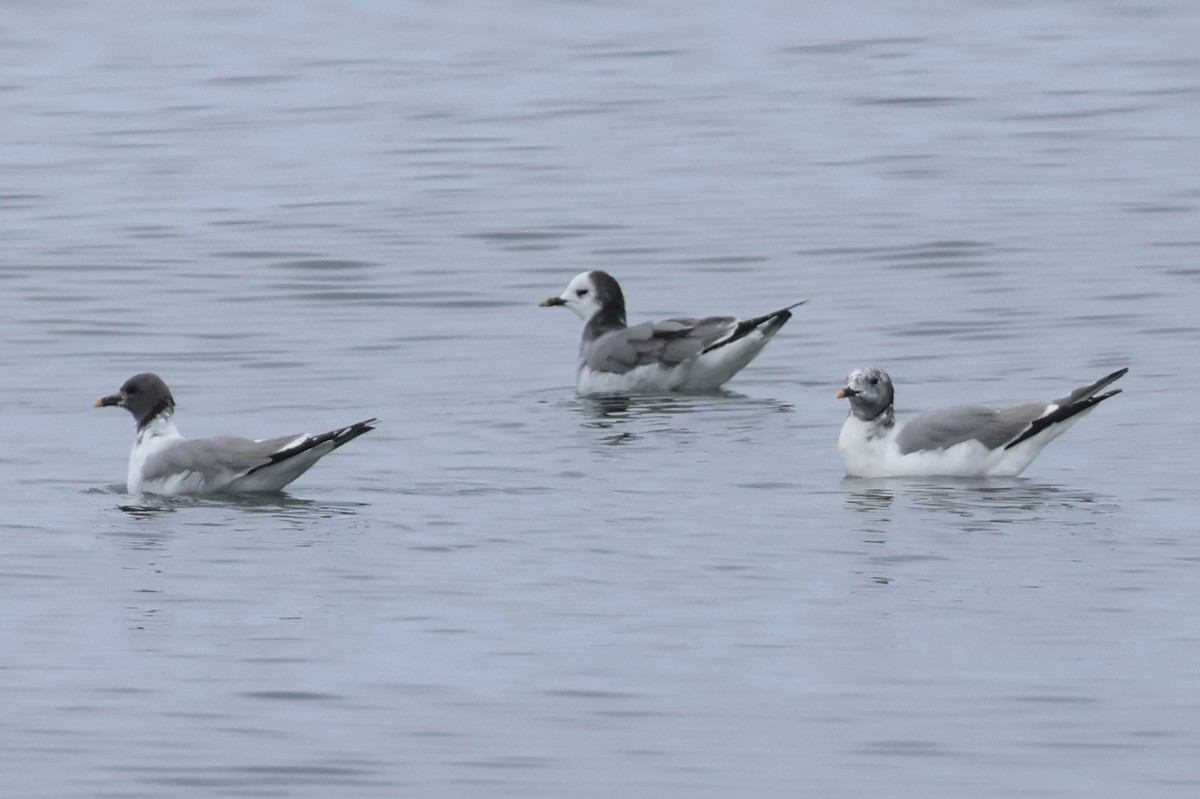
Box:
838;368;1129;477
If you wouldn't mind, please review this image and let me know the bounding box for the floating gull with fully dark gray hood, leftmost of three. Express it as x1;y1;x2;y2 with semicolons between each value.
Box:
96;372;379;494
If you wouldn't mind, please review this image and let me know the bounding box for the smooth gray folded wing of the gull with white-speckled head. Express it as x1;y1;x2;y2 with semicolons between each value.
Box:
896;402;1046;455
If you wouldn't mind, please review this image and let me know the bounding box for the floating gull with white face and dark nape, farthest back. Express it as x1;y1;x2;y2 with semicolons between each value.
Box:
541;271;808;394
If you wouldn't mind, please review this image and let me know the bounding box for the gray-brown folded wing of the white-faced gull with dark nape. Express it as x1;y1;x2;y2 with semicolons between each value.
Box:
583;317;738;374
